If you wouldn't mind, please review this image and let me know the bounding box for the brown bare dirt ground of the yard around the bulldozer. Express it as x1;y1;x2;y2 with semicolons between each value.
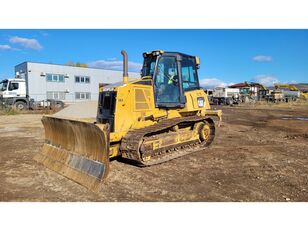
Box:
0;105;308;201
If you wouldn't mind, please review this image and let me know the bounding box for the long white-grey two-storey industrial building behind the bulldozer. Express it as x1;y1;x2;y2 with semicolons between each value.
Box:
15;62;140;102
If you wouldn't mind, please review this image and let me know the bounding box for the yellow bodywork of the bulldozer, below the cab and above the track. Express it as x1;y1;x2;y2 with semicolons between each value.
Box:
100;77;221;147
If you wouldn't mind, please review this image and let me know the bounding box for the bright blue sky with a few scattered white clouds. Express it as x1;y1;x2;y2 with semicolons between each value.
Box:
0;30;308;87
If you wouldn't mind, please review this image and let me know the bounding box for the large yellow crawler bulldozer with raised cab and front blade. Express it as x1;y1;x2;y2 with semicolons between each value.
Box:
35;50;222;192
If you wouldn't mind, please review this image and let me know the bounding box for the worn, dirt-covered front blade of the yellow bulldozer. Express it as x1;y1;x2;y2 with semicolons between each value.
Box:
34;116;109;193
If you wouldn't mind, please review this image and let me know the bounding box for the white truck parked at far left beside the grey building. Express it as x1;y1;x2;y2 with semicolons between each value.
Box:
0;78;64;110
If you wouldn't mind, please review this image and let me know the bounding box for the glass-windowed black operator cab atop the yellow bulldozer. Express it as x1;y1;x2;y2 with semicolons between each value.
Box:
141;50;200;108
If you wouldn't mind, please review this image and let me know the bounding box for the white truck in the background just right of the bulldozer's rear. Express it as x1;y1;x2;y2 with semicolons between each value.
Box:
211;87;240;105
